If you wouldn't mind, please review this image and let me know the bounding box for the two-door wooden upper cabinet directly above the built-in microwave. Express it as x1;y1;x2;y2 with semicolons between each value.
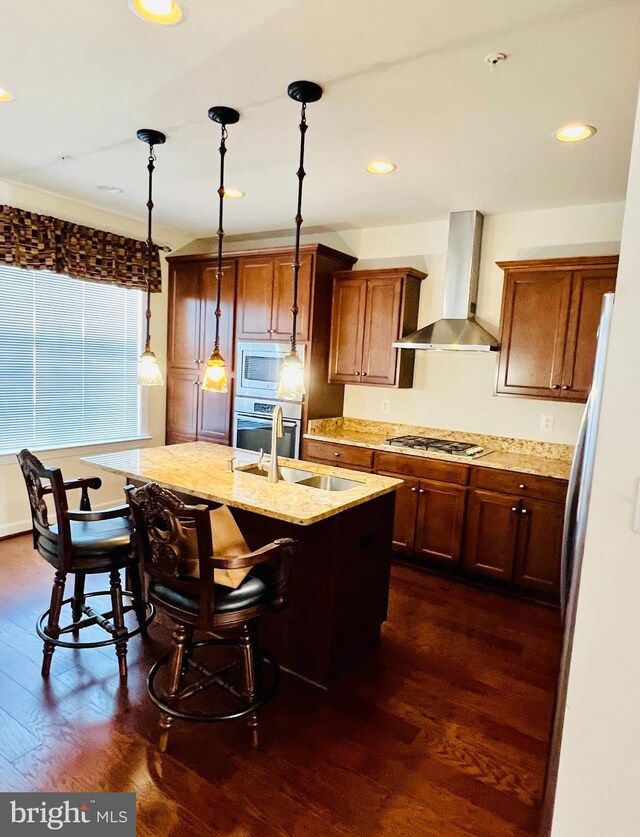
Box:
237;253;313;342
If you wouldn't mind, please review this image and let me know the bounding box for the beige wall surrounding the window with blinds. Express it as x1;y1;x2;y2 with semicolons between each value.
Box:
0;181;189;537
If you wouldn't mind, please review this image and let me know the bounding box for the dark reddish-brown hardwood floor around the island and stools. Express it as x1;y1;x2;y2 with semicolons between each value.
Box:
0;536;561;837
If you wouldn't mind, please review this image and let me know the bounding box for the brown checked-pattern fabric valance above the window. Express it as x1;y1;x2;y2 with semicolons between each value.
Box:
0;204;161;291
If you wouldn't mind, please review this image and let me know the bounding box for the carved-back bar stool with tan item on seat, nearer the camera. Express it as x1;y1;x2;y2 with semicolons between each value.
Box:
125;483;295;752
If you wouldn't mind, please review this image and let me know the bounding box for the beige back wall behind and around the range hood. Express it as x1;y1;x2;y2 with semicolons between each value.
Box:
194;203;624;444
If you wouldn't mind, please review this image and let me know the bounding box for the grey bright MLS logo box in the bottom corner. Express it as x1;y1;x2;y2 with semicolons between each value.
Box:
0;793;136;837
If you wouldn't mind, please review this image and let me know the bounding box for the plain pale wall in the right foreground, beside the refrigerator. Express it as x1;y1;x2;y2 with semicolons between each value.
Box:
553;91;640;837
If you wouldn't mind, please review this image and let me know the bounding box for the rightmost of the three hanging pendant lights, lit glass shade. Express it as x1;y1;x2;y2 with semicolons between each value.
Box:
277;81;322;401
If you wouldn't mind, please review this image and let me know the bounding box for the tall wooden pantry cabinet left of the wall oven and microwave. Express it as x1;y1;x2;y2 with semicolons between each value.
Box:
166;261;235;444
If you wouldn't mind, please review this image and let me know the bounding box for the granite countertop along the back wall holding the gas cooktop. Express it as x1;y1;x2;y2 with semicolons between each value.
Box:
305;417;573;480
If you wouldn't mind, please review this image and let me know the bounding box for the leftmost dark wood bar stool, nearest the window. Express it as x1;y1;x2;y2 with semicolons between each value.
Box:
18;449;154;677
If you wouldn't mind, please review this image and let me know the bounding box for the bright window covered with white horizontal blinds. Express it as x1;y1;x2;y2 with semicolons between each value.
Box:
0;265;143;453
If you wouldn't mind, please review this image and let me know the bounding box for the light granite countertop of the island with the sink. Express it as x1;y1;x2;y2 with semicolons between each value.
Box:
82;442;402;526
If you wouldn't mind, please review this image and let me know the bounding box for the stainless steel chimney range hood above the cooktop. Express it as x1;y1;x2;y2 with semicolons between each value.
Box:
392;210;498;352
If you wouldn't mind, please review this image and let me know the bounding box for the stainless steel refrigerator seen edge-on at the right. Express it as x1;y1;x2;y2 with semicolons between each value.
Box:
540;294;615;835
